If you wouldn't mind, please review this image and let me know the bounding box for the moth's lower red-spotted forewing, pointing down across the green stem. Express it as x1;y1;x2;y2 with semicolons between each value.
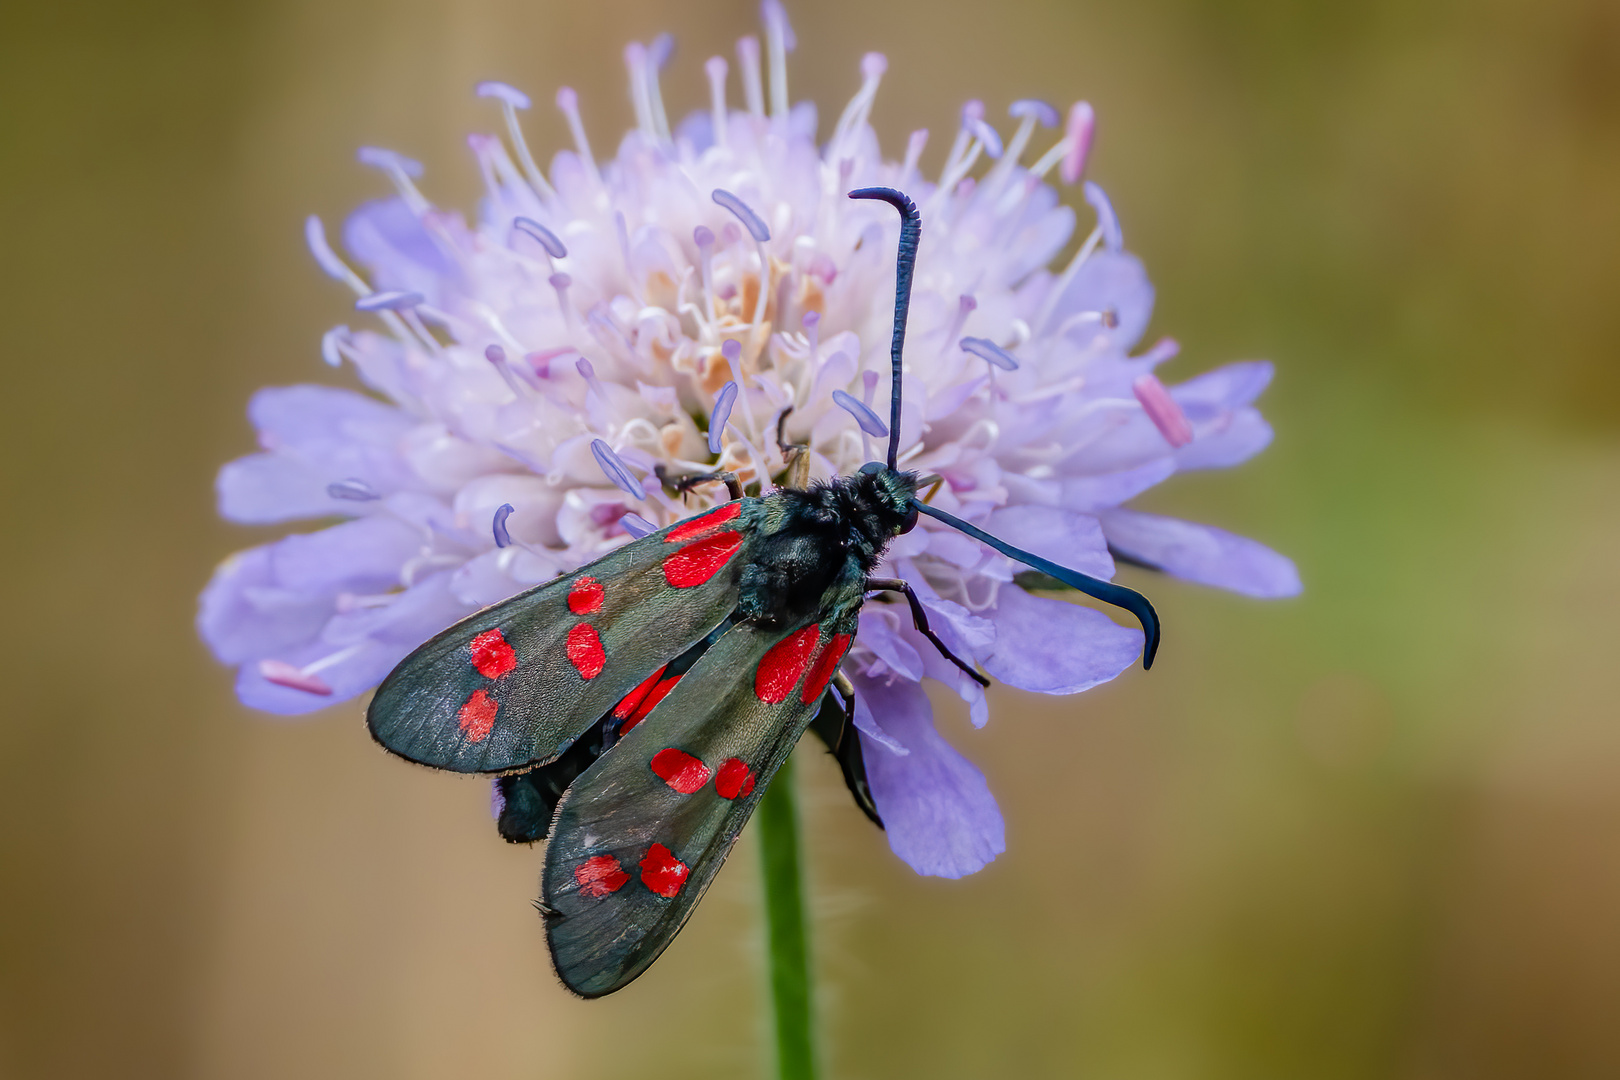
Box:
541;608;860;997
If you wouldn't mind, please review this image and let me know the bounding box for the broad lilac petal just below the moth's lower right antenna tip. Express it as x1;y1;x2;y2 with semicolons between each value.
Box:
985;585;1142;693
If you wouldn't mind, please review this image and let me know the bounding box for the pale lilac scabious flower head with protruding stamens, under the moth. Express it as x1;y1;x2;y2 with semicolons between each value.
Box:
198;0;1299;876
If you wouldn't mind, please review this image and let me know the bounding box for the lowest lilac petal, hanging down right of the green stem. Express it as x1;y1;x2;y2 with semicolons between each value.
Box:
855;677;1006;878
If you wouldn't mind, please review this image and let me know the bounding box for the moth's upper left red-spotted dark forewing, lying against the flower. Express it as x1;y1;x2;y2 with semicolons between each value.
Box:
366;499;760;772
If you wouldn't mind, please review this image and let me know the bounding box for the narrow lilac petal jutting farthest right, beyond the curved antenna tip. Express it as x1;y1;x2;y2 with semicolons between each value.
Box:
1102;510;1301;599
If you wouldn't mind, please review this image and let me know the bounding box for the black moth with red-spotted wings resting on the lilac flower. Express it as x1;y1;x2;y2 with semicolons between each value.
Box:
366;188;1158;997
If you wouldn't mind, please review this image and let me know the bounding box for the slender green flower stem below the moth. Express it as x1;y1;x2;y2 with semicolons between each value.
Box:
760;758;815;1080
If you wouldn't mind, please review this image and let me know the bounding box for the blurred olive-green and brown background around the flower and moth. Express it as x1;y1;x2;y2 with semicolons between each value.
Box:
0;0;1620;1080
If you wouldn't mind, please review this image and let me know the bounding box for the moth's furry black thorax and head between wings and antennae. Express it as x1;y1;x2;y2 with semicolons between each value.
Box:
739;470;917;620
